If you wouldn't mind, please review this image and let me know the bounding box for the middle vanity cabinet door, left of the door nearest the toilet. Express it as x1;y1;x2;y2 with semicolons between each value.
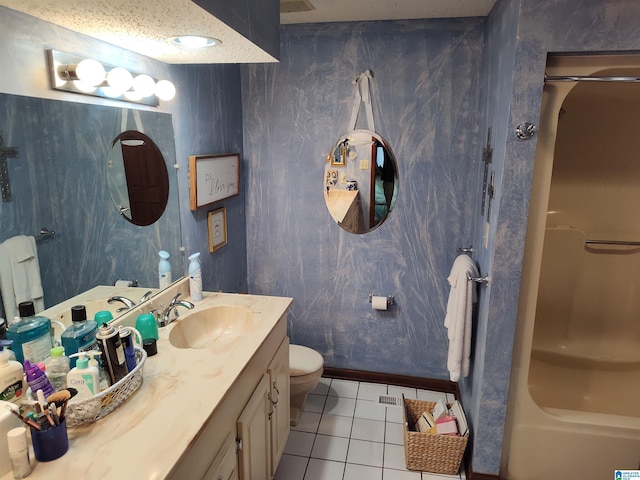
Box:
237;373;271;480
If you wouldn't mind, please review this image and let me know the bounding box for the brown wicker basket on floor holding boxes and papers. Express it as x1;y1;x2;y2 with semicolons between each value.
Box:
402;398;469;475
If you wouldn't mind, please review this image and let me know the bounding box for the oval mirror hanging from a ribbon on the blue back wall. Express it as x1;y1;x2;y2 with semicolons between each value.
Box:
324;130;398;233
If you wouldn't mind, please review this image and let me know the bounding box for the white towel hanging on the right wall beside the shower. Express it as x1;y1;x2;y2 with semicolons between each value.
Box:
444;254;479;382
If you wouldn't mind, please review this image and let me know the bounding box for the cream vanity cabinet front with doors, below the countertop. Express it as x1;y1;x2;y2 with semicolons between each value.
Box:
168;314;289;480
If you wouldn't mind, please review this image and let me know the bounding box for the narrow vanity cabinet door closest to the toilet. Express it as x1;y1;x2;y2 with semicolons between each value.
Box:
267;337;290;477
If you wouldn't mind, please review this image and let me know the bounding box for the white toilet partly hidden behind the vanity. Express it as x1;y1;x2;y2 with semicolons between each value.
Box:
289;345;324;425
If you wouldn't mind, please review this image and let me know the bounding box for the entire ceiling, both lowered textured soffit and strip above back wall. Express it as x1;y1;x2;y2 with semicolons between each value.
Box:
0;0;496;64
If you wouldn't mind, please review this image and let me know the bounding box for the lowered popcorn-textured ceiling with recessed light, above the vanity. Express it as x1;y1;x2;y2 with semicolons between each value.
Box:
0;0;276;63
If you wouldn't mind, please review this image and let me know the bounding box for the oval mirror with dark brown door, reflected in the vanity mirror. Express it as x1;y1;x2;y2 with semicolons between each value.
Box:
106;130;169;226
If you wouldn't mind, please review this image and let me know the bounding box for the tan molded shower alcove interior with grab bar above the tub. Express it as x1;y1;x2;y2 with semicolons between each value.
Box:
529;58;640;417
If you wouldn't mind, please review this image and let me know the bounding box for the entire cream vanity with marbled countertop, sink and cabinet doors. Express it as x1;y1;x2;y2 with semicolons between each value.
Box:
0;279;292;480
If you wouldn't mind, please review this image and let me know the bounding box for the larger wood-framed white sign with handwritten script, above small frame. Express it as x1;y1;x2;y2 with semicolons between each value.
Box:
189;153;240;211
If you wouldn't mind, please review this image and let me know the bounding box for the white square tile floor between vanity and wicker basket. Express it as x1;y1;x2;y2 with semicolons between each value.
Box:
274;378;466;480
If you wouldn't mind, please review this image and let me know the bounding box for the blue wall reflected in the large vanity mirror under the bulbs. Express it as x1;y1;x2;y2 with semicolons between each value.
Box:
0;94;185;316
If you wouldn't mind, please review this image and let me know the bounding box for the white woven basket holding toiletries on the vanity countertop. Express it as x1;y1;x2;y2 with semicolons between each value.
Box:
65;347;147;427
